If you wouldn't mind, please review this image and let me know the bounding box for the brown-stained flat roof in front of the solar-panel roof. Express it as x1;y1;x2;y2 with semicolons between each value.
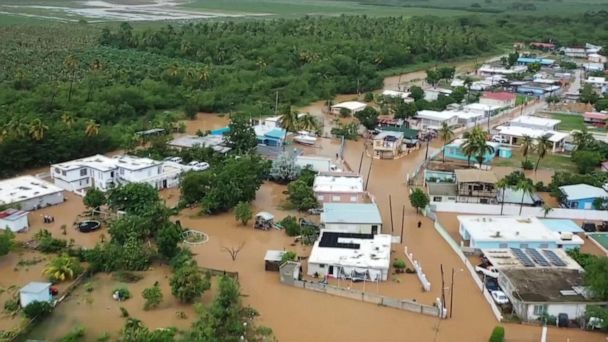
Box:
501;268;606;303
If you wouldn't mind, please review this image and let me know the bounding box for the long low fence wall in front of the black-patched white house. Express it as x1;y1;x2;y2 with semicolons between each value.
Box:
283;280;447;318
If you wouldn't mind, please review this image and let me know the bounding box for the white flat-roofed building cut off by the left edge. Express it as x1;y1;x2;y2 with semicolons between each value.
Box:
0;176;64;211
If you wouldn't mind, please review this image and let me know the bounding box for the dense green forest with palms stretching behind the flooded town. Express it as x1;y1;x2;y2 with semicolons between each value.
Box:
0;16;608;177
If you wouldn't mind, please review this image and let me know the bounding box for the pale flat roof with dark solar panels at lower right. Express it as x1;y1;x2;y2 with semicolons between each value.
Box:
481;248;583;271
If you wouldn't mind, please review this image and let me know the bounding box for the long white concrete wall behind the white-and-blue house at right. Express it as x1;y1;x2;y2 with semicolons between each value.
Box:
431;202;608;221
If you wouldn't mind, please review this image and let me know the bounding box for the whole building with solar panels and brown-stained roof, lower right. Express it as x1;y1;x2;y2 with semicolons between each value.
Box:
482;249;606;322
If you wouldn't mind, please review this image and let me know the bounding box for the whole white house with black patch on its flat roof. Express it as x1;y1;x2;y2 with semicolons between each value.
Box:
307;230;391;281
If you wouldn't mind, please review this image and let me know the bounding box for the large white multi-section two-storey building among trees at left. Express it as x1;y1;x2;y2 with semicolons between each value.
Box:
51;154;185;192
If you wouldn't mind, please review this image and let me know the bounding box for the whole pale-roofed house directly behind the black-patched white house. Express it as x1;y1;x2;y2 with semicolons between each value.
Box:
321;203;382;235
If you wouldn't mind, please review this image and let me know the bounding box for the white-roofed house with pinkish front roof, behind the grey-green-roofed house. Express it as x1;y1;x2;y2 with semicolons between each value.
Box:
312;172;367;203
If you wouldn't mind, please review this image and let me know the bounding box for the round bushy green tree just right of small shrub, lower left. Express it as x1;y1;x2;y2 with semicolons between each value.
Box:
169;265;211;303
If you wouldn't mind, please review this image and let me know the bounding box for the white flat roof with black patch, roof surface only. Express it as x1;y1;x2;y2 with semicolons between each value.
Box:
308;231;391;270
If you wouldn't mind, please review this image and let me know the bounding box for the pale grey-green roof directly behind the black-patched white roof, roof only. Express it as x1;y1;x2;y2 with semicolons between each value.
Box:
321;203;382;224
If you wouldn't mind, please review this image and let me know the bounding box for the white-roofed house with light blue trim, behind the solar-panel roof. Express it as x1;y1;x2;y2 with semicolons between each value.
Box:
458;215;584;249
